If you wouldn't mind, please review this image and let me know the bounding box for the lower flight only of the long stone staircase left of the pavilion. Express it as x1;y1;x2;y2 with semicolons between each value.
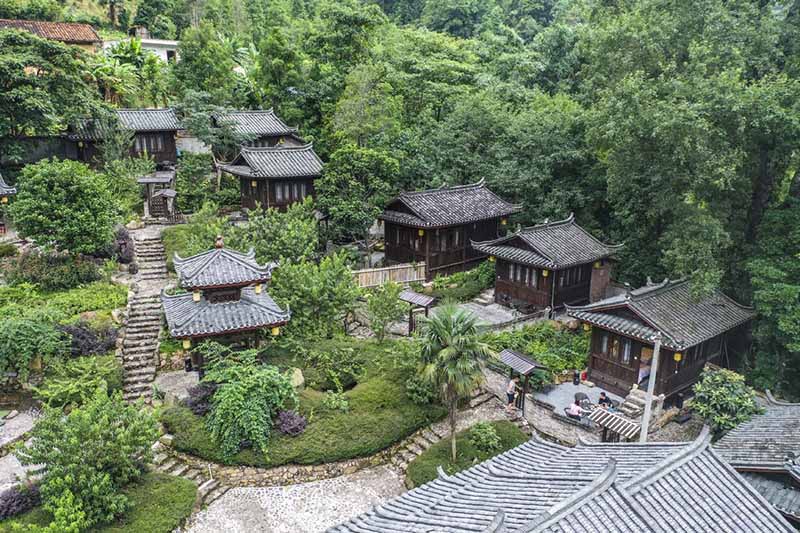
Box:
122;294;161;402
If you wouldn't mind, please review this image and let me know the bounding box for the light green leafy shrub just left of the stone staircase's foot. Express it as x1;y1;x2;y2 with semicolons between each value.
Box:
34;355;122;407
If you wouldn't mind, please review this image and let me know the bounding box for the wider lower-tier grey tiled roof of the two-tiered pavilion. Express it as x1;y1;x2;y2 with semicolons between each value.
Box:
161;287;291;338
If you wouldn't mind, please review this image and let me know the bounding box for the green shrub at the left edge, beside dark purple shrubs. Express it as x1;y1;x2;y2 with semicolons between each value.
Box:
0;318;69;383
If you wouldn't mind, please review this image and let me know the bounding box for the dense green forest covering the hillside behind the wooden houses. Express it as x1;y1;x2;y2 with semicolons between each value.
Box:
0;0;800;395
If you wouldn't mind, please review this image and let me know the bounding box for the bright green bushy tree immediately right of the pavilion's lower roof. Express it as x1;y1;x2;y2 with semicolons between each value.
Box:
270;253;359;338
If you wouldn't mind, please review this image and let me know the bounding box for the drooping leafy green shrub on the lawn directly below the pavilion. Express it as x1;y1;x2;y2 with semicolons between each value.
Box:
205;350;296;456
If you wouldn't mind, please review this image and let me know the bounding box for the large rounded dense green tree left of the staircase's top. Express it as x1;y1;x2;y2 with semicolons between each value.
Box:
9;159;117;254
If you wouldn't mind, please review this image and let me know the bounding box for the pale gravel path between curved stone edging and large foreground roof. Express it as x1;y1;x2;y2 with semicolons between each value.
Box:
186;466;405;533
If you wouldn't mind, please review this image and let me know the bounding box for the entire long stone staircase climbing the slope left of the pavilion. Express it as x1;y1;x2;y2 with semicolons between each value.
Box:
122;226;167;402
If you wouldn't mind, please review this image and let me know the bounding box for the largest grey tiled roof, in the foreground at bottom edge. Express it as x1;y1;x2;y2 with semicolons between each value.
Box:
329;430;794;533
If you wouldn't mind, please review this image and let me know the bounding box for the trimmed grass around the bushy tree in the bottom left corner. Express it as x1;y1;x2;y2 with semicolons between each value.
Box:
0;472;197;533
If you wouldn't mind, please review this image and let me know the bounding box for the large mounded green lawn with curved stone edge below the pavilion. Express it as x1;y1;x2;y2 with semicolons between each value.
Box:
161;339;445;467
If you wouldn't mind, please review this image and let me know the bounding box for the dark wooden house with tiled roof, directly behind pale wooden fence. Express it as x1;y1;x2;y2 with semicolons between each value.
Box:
378;180;520;279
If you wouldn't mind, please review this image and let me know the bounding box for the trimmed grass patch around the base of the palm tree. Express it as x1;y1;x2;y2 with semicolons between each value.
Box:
406;420;529;487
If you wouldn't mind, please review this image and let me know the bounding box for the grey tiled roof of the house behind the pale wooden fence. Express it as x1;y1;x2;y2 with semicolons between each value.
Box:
379;180;520;228
